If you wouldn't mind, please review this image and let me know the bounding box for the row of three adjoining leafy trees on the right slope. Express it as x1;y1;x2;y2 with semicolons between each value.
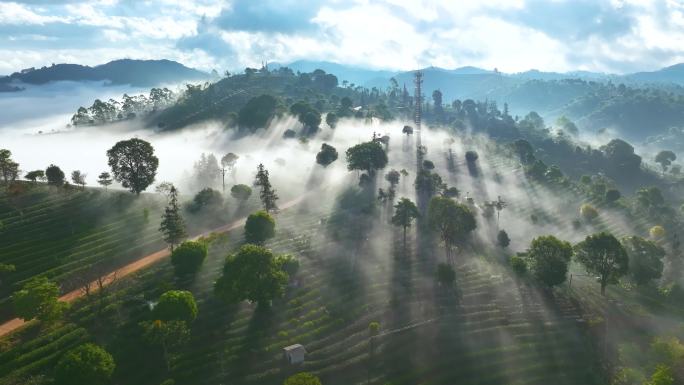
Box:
510;232;665;294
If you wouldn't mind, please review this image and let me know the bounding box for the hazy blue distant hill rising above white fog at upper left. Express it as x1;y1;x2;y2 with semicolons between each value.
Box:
0;59;209;91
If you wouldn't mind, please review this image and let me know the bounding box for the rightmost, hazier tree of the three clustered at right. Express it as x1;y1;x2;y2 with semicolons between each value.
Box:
621;236;665;285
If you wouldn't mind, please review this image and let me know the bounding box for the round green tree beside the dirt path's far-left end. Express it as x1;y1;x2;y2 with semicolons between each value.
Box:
12;277;63;321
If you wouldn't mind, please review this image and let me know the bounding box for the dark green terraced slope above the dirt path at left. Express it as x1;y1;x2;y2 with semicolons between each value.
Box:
0;185;163;319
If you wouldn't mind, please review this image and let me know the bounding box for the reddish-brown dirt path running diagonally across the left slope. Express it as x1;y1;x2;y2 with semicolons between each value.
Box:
0;196;304;337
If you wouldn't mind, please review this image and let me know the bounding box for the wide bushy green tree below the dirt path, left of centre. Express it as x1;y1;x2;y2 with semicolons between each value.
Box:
214;244;288;305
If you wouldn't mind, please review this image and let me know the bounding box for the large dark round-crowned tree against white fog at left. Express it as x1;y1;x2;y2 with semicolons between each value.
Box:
107;138;159;195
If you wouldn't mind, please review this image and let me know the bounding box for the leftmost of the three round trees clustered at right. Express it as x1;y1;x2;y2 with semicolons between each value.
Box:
527;235;572;286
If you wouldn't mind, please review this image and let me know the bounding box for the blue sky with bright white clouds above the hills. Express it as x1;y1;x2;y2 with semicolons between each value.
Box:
0;0;684;74
